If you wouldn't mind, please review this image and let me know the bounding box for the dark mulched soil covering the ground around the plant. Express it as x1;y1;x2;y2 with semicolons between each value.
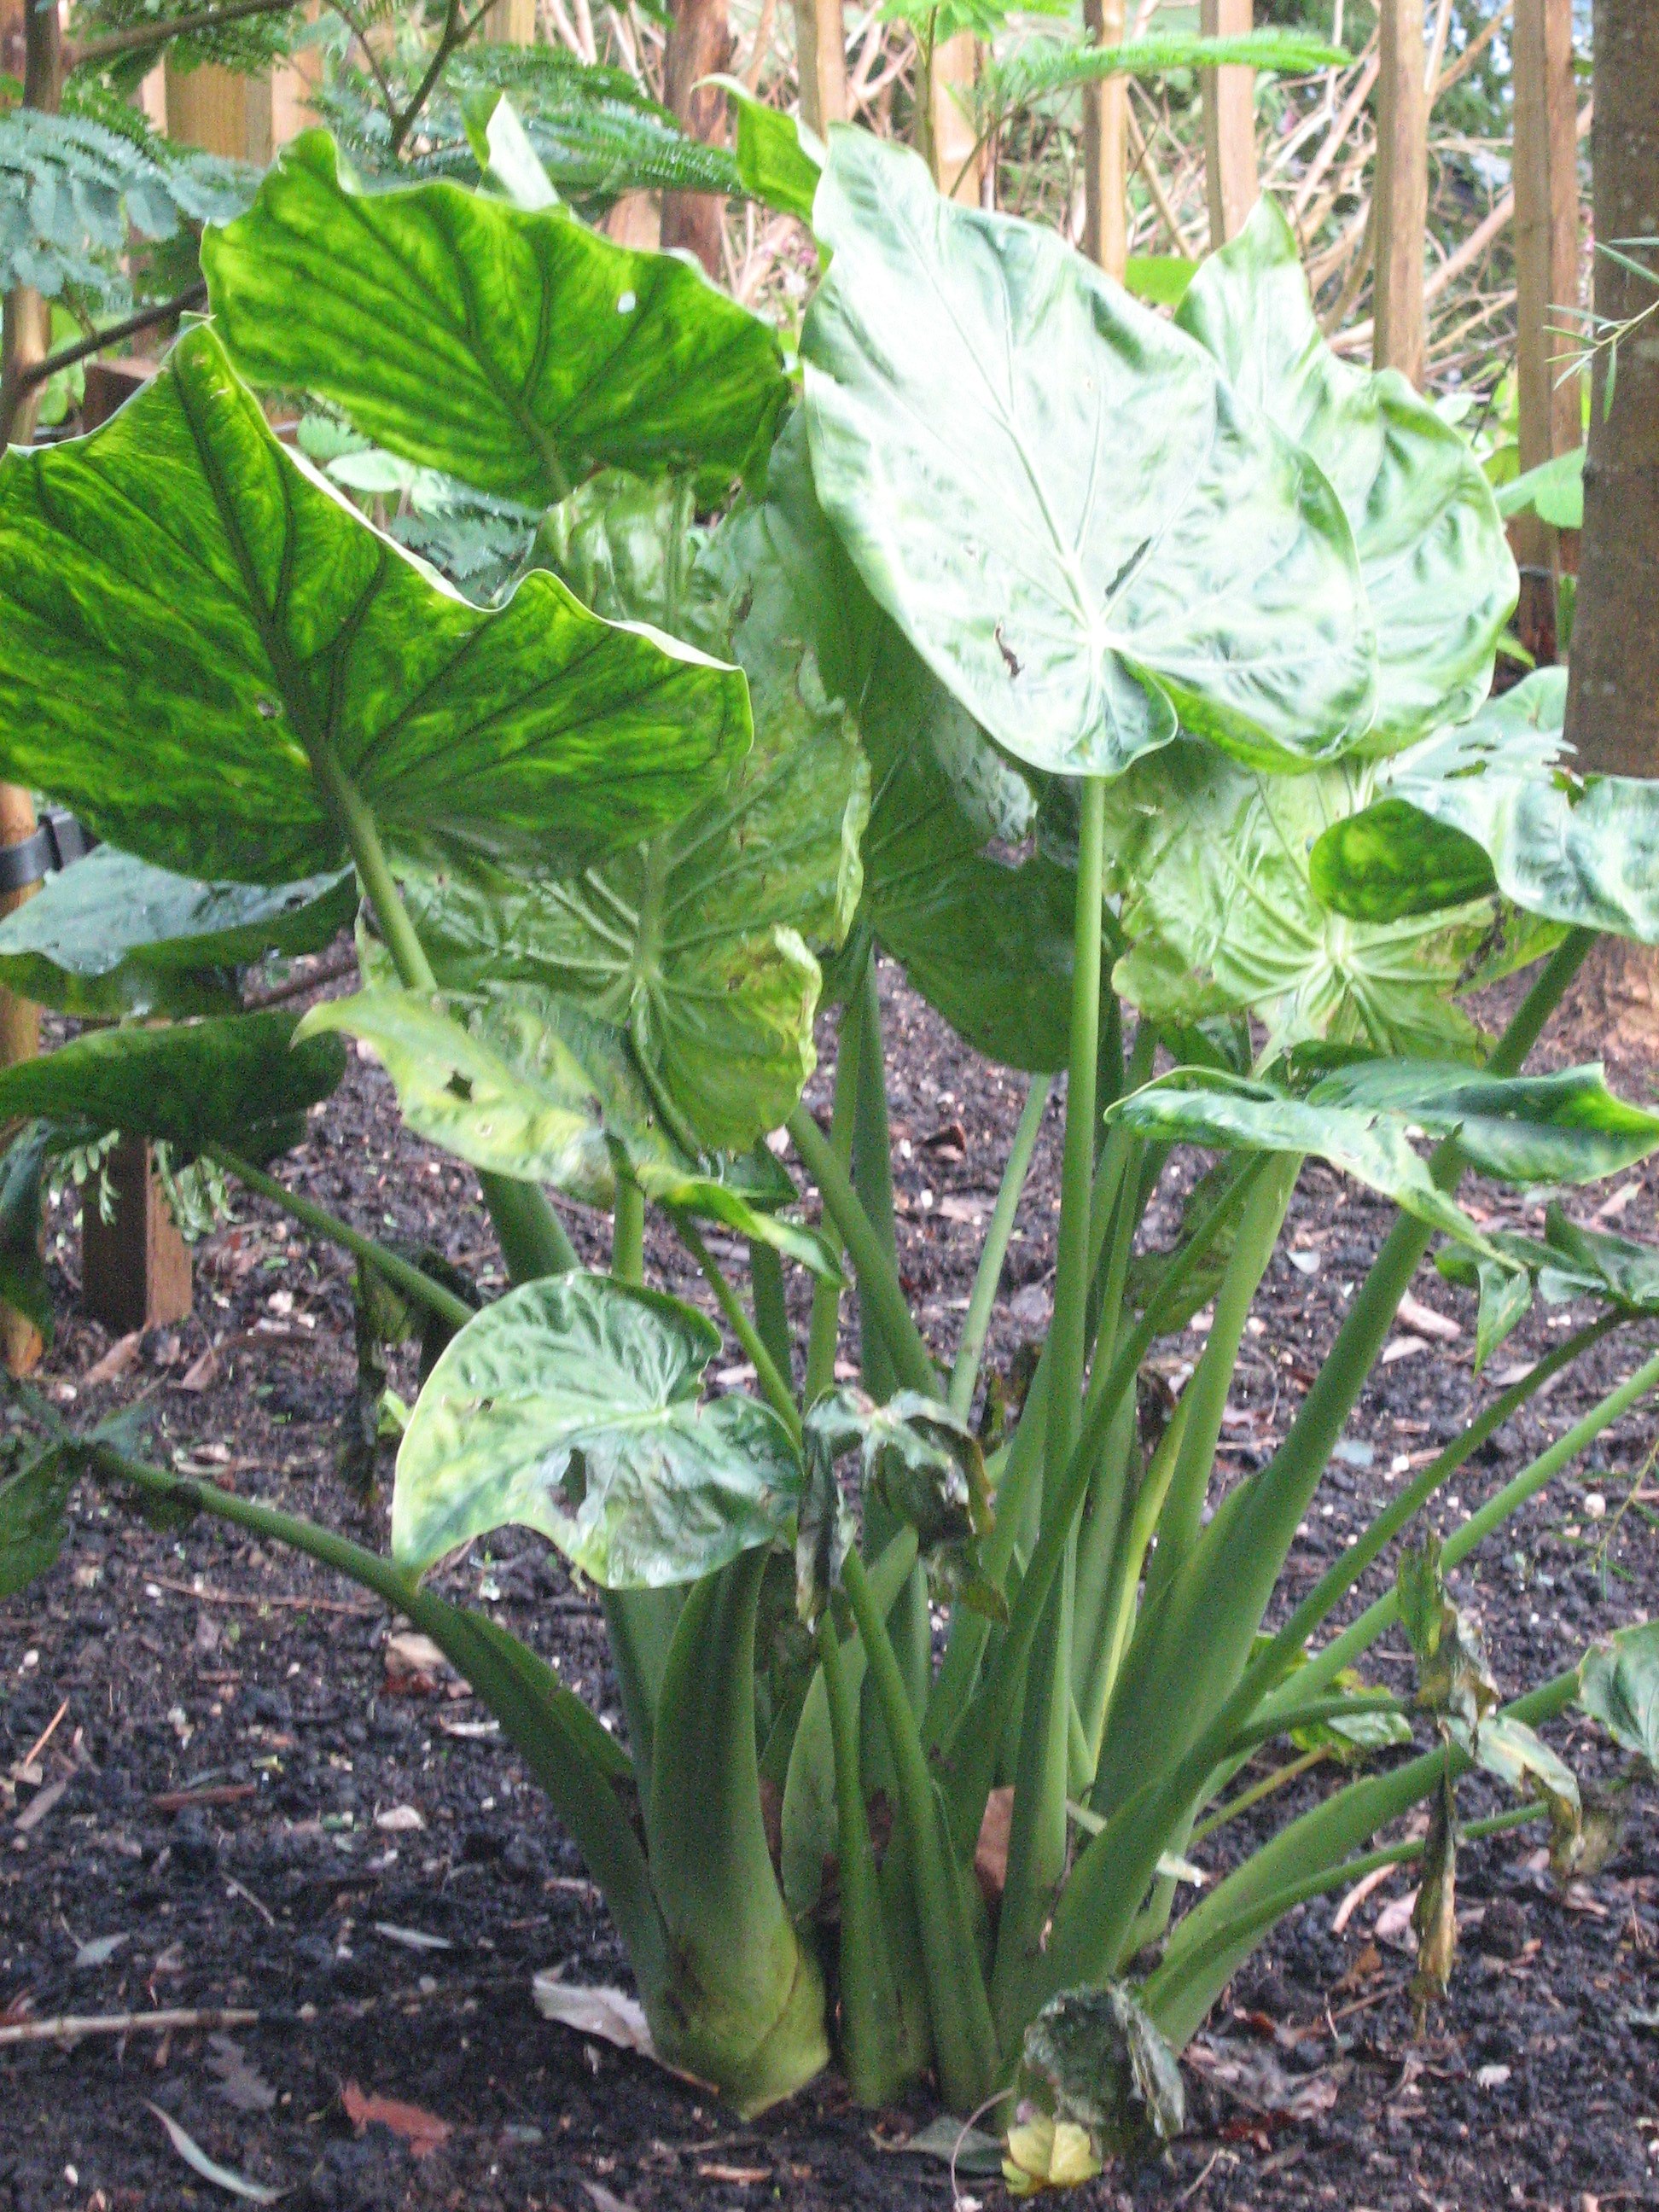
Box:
0;955;1659;2212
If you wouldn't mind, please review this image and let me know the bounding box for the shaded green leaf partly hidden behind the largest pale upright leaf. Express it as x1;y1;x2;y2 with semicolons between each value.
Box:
695;414;1075;1071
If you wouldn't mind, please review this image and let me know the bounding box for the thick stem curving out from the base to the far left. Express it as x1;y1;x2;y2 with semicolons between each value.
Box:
86;1445;666;1988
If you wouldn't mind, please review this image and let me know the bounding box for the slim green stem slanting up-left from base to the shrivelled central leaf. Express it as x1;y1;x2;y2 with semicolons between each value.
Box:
843;1551;1000;2112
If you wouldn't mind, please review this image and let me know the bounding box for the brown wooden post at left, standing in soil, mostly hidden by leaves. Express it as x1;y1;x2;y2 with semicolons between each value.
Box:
79;364;193;1336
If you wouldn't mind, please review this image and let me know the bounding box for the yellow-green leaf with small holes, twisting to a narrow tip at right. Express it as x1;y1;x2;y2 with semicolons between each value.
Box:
303;982;838;1281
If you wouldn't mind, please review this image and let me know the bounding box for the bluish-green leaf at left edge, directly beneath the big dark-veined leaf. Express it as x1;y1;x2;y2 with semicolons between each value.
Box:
0;845;356;1022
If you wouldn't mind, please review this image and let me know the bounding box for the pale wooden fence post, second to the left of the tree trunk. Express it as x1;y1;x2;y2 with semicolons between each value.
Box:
1371;0;1429;389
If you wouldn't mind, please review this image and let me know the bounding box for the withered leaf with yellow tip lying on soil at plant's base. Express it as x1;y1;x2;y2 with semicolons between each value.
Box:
1004;1982;1185;2197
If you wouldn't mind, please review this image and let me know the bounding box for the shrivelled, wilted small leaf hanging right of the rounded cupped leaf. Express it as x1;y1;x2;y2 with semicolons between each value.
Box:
796;1387;1009;1619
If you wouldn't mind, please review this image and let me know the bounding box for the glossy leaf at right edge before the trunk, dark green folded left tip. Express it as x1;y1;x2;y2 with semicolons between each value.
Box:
1312;668;1659;945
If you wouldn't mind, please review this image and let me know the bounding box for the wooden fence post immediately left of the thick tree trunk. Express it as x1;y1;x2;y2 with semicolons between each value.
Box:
1511;0;1581;666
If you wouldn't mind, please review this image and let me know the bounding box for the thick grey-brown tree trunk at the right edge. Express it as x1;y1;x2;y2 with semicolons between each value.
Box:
1566;0;1659;1042
